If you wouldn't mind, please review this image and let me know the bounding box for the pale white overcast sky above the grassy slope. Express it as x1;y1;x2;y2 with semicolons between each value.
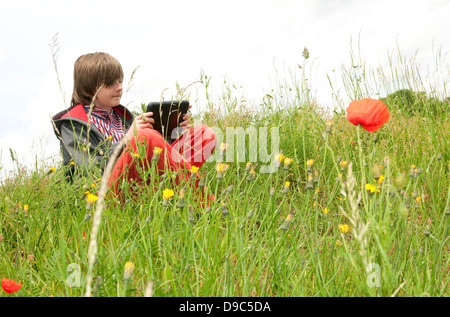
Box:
0;0;450;175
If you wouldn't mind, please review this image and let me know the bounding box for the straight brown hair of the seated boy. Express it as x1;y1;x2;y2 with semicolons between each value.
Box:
70;52;123;107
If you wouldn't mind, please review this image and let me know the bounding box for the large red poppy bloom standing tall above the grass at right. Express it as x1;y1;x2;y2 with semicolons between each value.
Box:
347;98;389;132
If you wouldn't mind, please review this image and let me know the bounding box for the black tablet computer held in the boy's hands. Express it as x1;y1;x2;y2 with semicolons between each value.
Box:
147;100;189;142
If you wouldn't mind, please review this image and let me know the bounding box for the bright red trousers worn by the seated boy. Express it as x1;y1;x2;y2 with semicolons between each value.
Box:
108;125;216;201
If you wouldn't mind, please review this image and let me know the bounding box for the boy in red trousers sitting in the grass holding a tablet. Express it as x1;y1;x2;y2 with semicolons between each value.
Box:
52;52;216;200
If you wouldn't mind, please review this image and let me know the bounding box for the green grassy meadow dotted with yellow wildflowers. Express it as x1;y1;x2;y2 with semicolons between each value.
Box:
0;44;450;297
